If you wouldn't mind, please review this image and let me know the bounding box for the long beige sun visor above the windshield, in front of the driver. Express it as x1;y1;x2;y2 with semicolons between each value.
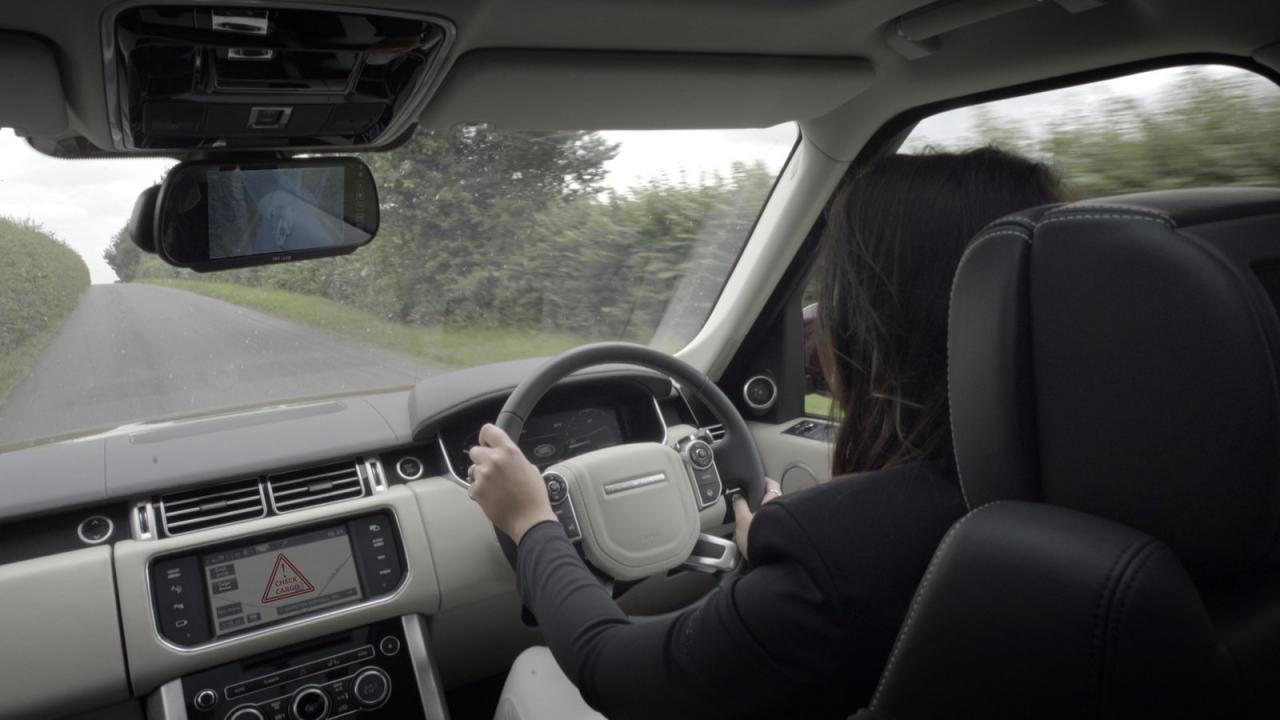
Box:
421;50;873;129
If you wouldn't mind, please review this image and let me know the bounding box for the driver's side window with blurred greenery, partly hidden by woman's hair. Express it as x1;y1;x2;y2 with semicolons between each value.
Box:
804;65;1280;416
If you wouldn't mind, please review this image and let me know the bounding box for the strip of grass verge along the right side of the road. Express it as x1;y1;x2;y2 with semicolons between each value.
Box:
136;274;593;368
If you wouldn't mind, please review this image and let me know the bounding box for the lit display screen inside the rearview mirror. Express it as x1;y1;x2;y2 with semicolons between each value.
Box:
209;167;350;260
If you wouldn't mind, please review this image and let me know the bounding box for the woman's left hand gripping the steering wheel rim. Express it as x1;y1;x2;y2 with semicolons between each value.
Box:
467;424;556;546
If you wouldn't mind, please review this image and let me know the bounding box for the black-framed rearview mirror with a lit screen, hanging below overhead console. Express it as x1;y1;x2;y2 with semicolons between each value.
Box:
155;158;379;272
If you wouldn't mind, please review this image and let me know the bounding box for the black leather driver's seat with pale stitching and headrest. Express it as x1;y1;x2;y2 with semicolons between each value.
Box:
860;188;1280;720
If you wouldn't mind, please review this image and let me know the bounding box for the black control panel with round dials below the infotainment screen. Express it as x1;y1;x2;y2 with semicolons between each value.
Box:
147;615;448;720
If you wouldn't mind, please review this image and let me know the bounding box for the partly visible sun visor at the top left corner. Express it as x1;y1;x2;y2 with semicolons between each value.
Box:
0;32;67;136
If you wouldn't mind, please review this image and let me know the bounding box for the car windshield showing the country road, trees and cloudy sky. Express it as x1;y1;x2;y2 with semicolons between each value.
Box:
0;124;797;450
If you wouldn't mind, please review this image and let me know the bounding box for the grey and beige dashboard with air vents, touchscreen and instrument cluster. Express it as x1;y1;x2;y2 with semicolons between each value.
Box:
0;361;724;720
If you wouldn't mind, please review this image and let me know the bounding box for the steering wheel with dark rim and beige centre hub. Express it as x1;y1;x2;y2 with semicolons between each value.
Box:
494;342;764;580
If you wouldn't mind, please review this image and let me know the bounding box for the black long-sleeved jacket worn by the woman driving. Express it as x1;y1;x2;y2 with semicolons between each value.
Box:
517;464;965;720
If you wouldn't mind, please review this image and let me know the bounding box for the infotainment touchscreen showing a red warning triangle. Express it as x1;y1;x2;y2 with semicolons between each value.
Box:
201;525;362;637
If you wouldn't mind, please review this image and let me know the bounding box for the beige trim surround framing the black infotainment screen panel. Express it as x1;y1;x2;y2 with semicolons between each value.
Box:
115;486;440;694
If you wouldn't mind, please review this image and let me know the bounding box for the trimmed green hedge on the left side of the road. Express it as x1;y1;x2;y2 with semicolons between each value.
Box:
0;218;88;401
